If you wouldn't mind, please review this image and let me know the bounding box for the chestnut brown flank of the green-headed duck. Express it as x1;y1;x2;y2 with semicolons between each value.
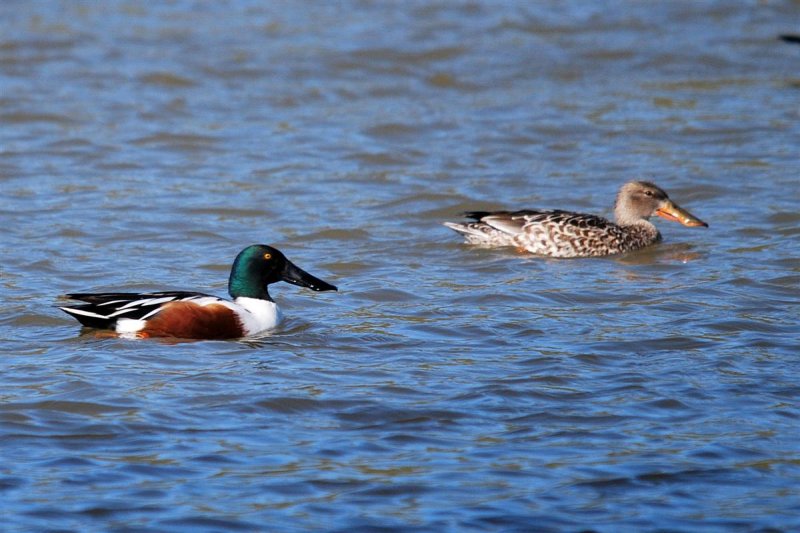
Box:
139;302;244;339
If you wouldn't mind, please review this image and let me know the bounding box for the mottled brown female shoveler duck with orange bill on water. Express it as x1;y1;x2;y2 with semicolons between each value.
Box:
444;181;708;257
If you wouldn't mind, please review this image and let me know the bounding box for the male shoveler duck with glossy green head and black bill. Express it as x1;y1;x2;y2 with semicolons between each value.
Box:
60;244;336;339
